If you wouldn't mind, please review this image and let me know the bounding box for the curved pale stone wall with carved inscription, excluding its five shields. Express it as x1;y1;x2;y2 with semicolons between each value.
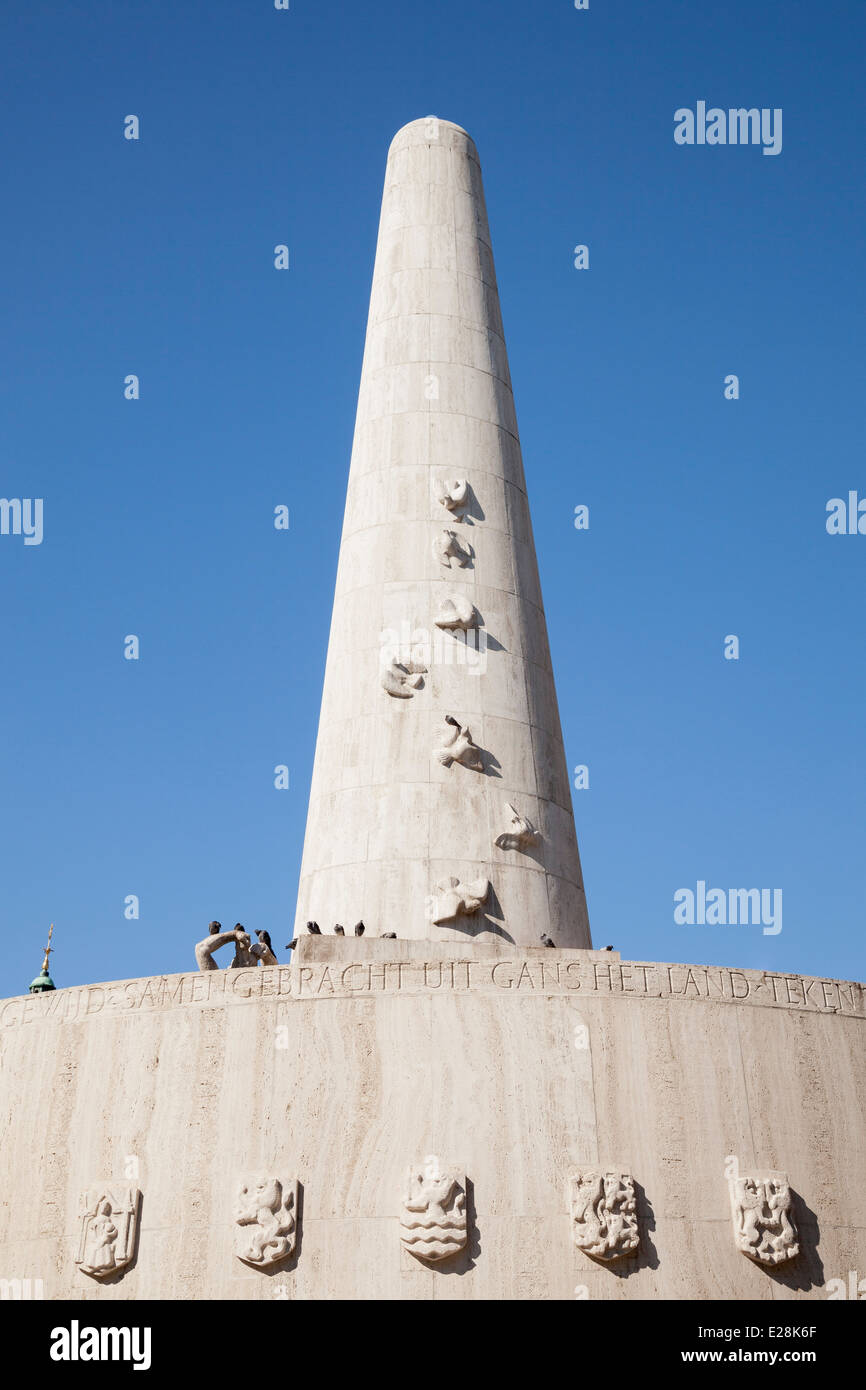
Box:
0;937;866;1300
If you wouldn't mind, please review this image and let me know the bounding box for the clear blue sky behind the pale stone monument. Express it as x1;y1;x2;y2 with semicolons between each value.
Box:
0;0;866;995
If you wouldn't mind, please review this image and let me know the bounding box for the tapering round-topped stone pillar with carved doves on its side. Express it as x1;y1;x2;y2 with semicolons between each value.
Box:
296;117;591;947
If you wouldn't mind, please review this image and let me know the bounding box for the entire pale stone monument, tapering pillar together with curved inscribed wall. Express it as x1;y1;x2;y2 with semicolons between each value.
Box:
0;118;866;1301
